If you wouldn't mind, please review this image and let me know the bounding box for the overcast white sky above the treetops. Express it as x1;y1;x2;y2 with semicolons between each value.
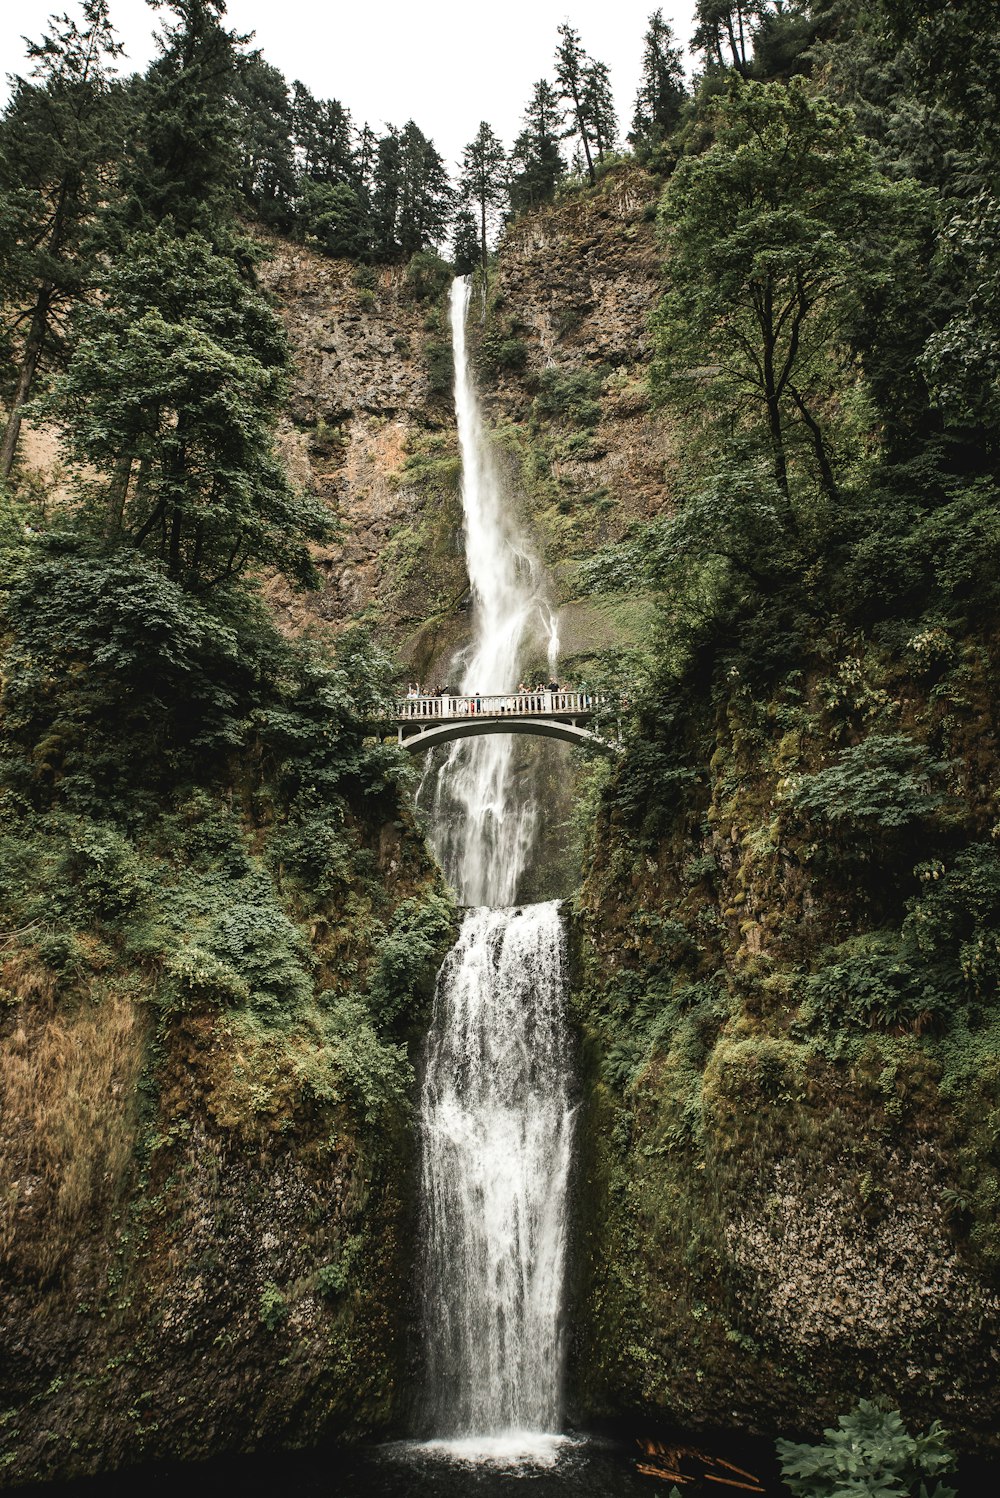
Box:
0;0;695;166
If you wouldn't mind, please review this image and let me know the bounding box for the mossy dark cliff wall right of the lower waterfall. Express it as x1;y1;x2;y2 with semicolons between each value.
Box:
565;640;1000;1449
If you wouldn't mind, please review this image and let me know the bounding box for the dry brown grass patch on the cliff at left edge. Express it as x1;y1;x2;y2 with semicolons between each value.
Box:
0;954;144;1278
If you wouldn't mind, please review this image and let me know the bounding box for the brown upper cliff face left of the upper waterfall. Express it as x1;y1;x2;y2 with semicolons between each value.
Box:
260;241;466;673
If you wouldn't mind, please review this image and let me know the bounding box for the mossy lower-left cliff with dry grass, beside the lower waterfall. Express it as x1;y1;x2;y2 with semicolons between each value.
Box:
0;784;449;1482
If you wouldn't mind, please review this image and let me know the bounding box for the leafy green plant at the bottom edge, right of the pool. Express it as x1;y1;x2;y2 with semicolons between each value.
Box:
777;1399;957;1498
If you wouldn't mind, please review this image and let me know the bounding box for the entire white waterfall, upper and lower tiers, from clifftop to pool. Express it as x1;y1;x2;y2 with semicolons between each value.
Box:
421;280;573;1459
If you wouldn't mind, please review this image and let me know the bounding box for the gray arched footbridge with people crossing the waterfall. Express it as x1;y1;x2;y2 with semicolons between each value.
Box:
392;692;618;753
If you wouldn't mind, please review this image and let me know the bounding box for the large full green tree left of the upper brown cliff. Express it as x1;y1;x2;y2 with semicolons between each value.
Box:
45;229;325;590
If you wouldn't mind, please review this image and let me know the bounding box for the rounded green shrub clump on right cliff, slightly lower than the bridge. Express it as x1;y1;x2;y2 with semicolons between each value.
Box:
790;734;949;831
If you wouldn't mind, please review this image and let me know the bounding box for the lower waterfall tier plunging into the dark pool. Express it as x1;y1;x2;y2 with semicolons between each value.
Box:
421;902;572;1437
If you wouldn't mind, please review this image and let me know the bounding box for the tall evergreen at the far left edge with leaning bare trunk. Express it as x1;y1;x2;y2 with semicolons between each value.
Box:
0;0;121;478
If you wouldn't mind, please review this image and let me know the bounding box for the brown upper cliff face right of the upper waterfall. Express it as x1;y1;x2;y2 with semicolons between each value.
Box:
472;169;670;674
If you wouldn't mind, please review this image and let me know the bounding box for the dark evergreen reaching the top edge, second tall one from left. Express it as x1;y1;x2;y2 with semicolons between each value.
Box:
123;0;247;243
